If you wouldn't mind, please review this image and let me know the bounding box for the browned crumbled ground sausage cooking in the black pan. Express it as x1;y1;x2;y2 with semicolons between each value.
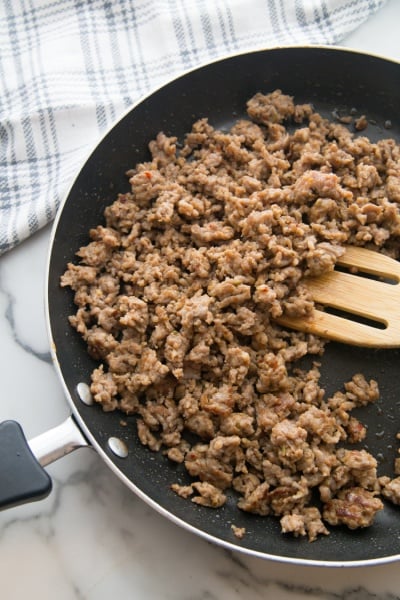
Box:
62;90;400;540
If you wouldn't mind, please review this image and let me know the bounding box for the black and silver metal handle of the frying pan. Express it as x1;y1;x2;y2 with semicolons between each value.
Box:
0;417;90;509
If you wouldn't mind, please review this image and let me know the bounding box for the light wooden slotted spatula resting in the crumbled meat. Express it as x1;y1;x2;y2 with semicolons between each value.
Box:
277;246;400;348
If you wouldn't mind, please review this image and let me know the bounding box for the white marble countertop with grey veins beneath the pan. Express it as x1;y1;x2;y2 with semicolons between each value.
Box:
0;0;400;600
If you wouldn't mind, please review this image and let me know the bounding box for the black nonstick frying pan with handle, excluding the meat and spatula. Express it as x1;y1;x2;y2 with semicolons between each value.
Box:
0;47;400;566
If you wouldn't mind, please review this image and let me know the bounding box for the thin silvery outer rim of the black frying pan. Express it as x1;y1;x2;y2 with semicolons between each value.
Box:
44;44;400;568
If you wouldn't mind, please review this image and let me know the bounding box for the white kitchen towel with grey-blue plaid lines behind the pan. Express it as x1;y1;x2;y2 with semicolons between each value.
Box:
0;0;385;253
